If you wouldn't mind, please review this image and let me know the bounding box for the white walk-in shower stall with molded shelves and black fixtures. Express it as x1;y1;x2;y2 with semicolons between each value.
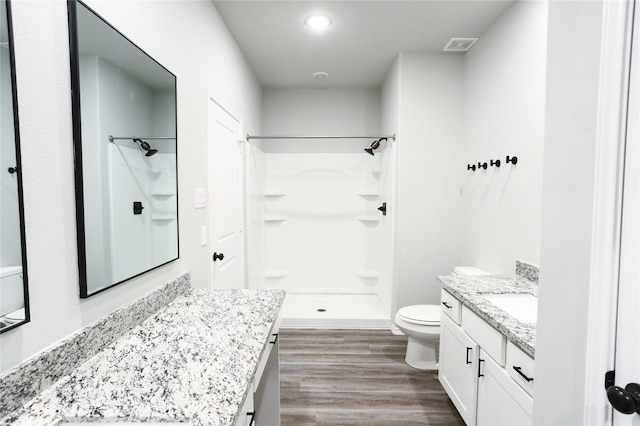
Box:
246;134;396;328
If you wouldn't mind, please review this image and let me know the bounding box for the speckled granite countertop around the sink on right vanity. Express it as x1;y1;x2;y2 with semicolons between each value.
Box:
438;274;538;358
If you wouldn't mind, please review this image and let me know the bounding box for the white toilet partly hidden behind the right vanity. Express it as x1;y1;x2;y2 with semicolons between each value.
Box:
393;266;491;370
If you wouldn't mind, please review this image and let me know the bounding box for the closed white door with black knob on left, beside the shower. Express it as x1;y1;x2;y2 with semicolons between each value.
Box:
208;97;244;288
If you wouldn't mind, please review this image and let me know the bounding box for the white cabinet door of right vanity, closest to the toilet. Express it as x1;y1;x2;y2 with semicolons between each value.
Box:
438;313;478;426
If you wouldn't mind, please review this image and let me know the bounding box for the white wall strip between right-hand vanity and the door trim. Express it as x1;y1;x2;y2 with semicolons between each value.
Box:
533;1;604;425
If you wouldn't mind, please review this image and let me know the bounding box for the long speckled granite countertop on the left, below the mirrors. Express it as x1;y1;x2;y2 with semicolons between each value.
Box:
4;289;284;426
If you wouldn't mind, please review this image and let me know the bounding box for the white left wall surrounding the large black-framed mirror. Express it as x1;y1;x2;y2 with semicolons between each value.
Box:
0;1;261;371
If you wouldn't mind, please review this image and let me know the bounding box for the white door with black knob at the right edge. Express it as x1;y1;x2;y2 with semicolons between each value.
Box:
613;2;640;426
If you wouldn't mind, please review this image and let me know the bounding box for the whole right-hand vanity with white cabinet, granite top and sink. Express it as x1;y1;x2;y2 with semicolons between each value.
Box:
438;275;538;426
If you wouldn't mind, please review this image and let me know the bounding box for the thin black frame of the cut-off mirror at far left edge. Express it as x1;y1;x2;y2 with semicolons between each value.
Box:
0;0;31;334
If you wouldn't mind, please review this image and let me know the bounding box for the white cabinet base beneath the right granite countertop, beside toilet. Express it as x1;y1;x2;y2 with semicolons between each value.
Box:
438;290;534;426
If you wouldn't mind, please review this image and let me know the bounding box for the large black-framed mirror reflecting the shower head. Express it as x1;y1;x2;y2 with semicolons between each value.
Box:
67;1;179;298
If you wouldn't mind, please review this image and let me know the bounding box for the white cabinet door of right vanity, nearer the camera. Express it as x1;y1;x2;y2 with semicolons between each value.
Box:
477;350;533;426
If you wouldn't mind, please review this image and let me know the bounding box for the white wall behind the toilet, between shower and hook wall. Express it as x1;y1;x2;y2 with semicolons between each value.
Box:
389;53;463;312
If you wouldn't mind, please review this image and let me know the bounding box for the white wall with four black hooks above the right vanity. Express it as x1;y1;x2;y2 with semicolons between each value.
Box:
455;1;547;274
